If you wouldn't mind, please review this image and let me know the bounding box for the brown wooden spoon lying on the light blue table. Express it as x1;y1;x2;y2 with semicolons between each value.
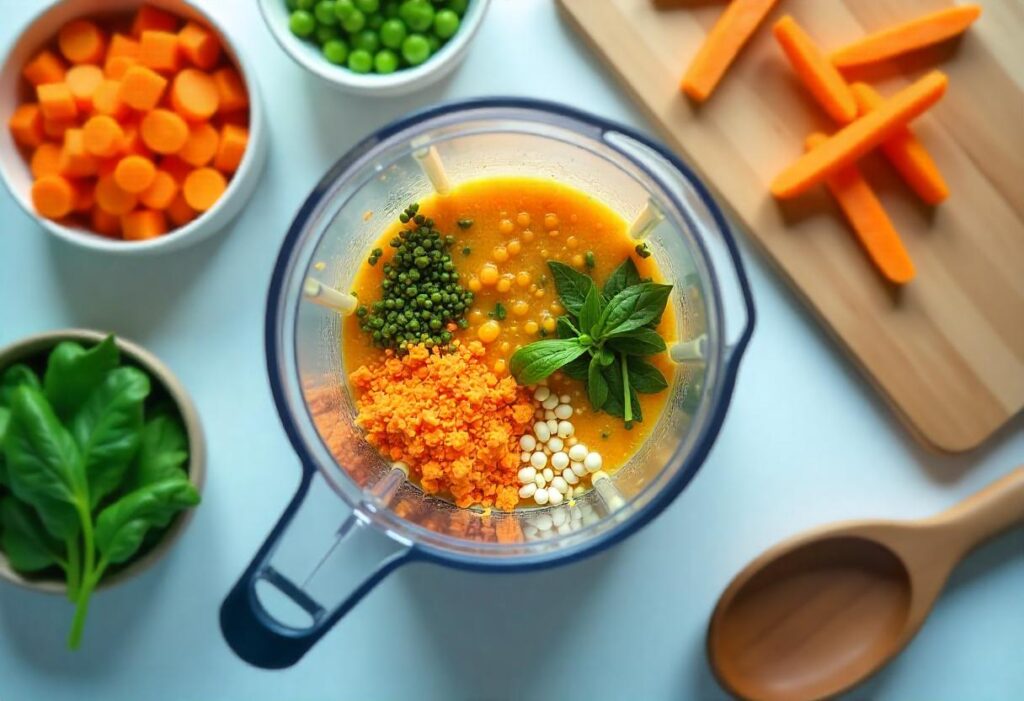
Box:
708;467;1024;701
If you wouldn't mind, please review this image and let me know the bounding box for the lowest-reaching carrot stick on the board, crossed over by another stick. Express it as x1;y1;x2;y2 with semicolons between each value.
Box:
807;133;914;284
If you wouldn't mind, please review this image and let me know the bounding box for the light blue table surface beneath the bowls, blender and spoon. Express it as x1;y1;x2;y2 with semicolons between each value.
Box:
0;0;1024;701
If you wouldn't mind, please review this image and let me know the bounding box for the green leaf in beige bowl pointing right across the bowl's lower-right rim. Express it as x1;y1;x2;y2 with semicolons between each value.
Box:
96;478;200;564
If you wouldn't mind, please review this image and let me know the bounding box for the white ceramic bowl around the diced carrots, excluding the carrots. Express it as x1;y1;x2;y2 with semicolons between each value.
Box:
0;0;268;255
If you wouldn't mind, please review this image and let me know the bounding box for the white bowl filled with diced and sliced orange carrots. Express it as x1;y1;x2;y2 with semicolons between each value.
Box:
0;0;266;253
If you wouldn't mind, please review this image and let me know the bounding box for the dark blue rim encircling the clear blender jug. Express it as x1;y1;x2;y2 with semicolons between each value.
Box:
268;97;757;573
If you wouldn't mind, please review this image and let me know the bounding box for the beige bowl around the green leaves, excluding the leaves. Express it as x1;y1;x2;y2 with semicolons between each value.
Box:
0;328;206;594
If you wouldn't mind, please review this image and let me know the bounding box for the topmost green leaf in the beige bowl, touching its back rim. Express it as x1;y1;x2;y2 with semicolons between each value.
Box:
43;336;121;421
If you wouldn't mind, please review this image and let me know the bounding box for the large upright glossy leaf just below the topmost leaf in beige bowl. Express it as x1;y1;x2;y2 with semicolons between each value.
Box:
71;367;150;507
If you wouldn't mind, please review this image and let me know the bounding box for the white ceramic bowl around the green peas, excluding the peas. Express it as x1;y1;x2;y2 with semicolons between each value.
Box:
259;0;490;95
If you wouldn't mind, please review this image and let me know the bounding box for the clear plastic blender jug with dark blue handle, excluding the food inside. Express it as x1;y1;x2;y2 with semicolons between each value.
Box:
221;99;754;668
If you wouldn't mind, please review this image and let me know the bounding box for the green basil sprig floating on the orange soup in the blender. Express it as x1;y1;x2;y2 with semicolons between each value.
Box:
511;258;672;427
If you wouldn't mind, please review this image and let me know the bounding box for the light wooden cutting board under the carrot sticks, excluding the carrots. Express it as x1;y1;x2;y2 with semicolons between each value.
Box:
559;0;1024;451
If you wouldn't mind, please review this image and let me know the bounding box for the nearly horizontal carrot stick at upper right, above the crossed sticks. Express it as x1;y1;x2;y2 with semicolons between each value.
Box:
831;5;981;69
